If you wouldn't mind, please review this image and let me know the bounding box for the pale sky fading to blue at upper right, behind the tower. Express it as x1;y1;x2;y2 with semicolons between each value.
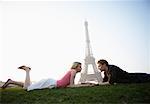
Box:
0;0;150;81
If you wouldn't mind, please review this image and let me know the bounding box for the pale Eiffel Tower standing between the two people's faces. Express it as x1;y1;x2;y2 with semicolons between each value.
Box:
79;21;102;83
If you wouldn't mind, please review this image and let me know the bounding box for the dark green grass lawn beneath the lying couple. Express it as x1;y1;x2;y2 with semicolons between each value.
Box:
0;83;150;104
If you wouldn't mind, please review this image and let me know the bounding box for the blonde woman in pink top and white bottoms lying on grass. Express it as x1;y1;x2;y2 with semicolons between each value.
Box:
2;62;94;91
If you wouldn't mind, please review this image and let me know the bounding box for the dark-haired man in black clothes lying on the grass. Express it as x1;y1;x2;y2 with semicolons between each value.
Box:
97;59;150;84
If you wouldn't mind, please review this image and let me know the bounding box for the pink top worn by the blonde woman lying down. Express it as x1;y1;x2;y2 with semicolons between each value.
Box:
57;70;71;87
